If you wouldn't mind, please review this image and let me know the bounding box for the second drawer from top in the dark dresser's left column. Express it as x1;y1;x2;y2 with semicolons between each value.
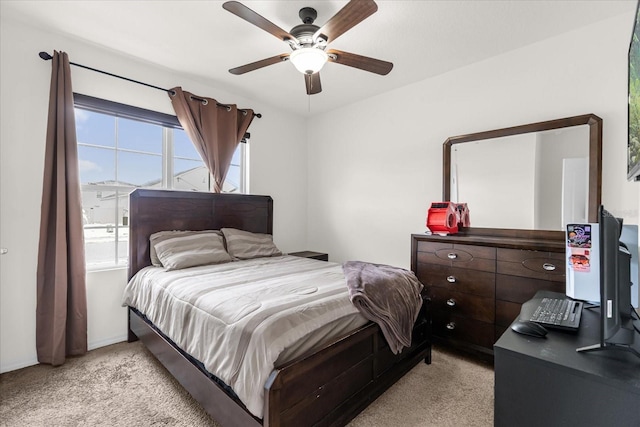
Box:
416;263;496;298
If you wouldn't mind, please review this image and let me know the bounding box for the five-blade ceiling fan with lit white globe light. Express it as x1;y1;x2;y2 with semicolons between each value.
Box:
222;0;393;95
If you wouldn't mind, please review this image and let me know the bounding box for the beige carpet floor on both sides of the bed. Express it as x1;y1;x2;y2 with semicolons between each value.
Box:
0;342;493;427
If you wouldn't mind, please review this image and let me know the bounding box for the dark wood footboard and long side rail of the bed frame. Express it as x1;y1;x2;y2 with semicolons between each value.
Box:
129;302;431;427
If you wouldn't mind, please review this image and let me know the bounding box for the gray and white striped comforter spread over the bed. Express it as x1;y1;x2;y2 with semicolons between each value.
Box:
123;256;367;418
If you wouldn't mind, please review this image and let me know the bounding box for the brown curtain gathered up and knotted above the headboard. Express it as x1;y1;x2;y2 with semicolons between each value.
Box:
169;87;253;193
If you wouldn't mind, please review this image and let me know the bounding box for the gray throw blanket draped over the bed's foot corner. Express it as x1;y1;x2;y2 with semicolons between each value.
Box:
342;261;423;354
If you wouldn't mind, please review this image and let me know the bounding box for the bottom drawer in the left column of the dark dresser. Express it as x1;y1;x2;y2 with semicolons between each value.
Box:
433;312;495;349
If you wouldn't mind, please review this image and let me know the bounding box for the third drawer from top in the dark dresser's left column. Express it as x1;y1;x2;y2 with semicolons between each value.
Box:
427;286;495;323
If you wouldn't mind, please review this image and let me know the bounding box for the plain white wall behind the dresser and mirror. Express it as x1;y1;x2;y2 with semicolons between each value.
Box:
308;14;640;268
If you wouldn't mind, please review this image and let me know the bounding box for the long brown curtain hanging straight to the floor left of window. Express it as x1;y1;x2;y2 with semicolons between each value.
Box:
36;52;87;366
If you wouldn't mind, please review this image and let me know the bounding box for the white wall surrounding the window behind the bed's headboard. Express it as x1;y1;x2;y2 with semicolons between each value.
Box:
0;18;307;372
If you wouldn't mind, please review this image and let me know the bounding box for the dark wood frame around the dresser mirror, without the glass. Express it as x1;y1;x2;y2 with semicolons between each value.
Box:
442;114;602;235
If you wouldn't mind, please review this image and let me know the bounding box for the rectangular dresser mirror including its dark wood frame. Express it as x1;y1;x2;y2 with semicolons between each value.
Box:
443;114;602;231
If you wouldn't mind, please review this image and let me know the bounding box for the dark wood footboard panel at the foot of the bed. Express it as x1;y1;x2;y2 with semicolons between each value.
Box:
264;310;431;426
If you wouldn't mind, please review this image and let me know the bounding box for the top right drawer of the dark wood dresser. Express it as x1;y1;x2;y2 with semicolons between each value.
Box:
497;248;565;282
